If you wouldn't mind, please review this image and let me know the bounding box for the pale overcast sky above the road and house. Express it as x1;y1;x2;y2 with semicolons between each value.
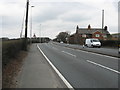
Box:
0;0;119;39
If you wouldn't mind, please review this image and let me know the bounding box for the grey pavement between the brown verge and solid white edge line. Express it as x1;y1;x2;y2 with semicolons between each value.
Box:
17;44;67;88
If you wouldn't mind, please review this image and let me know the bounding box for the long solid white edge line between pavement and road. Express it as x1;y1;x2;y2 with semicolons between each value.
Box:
37;45;74;90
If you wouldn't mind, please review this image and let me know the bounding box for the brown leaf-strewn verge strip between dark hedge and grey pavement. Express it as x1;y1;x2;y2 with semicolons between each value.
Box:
2;51;27;88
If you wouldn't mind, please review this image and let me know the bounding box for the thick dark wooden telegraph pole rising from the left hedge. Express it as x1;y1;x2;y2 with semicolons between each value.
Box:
25;0;29;50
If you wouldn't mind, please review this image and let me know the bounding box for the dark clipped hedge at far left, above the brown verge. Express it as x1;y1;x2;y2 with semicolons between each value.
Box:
2;39;23;66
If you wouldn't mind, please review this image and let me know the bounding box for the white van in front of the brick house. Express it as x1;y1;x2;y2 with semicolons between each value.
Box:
85;38;101;48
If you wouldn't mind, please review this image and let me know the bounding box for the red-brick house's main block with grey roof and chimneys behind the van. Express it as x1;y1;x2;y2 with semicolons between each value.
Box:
76;25;110;39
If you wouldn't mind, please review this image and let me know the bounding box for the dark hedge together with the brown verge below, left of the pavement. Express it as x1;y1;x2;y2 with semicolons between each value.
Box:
2;39;27;88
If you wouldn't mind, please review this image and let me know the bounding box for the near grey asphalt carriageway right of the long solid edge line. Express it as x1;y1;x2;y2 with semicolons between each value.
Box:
38;43;120;88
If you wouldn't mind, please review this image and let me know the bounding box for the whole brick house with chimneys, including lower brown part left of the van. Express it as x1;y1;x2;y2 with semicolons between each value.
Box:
69;25;110;44
